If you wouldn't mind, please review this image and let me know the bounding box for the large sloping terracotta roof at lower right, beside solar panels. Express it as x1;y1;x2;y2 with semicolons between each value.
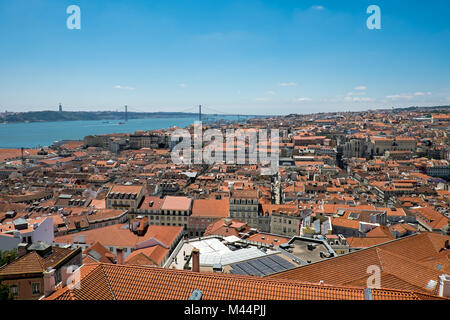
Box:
269;232;450;294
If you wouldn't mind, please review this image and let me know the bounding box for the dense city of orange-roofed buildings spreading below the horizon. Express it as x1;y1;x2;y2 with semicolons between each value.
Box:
0;109;450;300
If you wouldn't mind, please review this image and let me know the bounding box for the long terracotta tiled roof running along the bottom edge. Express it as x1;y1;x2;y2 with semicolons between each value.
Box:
46;264;439;300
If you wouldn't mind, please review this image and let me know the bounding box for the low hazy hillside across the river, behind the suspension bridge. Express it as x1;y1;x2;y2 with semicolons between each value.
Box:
0;111;197;122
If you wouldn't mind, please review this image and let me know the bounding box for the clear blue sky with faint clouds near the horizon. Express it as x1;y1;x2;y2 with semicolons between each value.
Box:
0;0;450;114
